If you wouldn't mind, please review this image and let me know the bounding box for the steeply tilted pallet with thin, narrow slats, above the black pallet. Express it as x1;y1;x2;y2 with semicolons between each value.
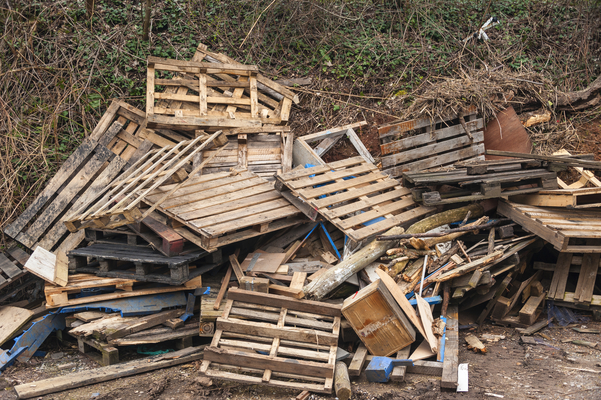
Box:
64;131;227;232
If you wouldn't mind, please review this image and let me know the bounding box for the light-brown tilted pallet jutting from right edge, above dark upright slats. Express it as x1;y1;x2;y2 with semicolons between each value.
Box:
497;200;601;253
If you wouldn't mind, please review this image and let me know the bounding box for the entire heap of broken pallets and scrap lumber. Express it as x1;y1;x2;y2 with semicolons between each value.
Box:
0;45;601;398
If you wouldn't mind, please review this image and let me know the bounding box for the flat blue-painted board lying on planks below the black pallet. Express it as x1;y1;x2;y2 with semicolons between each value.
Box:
58;292;186;317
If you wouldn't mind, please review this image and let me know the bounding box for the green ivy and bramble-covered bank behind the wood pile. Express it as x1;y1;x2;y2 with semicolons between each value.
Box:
0;0;601;245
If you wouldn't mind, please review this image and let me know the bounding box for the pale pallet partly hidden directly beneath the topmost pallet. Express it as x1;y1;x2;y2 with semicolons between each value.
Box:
199;126;294;180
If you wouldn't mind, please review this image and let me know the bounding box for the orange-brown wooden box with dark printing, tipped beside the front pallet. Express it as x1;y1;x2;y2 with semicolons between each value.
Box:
342;280;415;356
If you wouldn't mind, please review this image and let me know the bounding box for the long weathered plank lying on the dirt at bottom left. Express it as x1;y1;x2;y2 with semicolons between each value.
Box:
15;346;204;399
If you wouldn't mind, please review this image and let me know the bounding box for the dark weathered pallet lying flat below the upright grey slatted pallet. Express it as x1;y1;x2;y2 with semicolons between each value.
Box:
403;162;557;206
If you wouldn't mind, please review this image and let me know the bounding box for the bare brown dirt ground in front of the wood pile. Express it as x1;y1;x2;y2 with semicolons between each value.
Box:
0;320;601;400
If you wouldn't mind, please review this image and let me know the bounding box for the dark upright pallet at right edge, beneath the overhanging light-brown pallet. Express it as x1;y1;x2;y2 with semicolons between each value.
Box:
547;252;601;308
